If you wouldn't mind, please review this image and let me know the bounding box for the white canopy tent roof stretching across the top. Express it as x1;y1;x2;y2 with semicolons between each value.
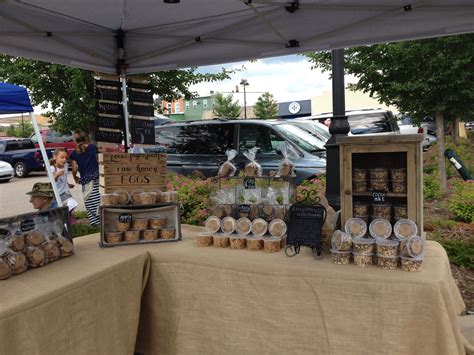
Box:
0;0;474;74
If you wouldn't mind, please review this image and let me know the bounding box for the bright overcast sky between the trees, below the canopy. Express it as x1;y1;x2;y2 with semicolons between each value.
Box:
191;55;356;105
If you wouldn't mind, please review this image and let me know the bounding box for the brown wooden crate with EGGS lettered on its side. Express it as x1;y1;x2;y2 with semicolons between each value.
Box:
99;153;166;193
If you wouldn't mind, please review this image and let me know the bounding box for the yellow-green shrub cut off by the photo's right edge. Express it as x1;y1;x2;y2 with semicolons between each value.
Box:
448;179;474;223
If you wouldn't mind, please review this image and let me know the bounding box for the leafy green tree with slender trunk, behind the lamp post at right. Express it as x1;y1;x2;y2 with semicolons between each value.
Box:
306;34;474;193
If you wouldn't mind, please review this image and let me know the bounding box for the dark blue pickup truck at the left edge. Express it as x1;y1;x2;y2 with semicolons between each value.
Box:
0;137;53;178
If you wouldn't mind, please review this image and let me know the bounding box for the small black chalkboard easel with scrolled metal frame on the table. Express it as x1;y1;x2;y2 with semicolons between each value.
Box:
285;190;327;259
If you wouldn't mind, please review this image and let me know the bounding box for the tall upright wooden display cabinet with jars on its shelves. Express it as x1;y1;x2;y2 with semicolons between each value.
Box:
337;134;423;234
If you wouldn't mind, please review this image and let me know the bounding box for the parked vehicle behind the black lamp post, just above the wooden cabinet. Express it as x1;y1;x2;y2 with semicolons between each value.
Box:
301;109;400;135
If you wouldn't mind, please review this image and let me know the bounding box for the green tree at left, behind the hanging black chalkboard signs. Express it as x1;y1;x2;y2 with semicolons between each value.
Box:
0;55;232;132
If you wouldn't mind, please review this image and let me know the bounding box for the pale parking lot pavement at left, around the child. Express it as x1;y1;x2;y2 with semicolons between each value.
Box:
0;173;85;218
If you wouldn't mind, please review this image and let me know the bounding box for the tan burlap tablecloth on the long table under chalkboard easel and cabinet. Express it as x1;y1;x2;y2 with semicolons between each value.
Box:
136;228;470;354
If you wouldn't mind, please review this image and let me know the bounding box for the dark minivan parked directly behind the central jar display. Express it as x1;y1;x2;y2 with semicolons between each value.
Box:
150;120;326;183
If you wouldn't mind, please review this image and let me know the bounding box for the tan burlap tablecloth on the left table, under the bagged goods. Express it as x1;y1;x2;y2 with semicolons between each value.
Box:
0;235;149;355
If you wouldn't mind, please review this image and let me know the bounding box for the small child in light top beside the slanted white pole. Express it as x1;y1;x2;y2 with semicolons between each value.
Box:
50;148;78;215
